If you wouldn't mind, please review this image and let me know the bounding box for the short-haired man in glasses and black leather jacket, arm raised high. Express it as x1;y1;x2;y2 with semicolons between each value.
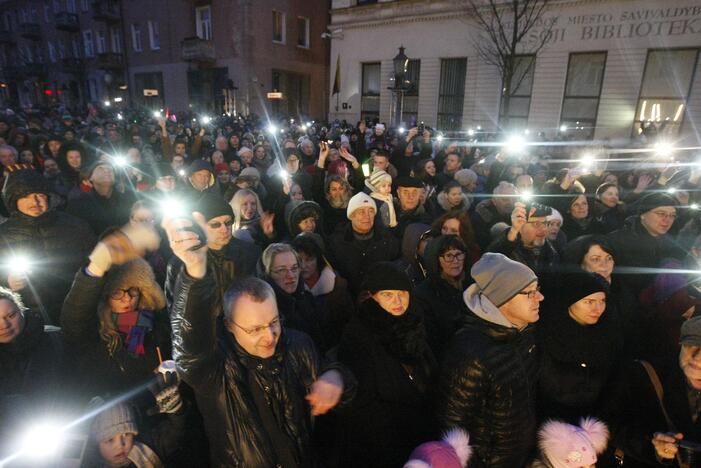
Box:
164;215;354;467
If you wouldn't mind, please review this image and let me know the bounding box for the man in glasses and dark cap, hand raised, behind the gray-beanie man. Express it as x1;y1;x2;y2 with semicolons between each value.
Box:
487;202;560;282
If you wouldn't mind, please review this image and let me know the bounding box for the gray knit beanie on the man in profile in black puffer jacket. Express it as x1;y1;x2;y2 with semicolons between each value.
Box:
470;253;538;307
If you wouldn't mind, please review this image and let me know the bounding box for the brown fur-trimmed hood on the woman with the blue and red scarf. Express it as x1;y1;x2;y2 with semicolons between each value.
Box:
102;258;166;310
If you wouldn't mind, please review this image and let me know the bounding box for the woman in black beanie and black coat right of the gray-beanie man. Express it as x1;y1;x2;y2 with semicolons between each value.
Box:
536;272;623;424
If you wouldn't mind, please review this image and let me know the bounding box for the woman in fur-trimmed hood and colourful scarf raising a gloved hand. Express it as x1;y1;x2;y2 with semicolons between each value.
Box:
61;238;170;397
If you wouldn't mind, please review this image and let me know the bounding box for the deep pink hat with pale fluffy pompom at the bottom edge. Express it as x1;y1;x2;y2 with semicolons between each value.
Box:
404;428;472;468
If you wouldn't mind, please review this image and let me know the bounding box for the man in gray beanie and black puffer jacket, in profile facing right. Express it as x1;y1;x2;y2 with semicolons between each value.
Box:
437;253;543;468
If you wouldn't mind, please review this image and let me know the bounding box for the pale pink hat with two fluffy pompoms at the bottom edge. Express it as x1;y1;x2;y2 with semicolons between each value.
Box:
538;418;609;468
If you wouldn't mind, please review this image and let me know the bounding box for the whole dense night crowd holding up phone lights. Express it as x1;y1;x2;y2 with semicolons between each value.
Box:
0;103;701;468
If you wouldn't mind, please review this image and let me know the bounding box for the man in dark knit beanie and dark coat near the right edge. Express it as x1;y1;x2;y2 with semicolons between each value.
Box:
609;192;686;297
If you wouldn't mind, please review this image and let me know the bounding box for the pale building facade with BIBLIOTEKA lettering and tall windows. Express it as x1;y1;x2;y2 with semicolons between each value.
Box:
329;0;701;144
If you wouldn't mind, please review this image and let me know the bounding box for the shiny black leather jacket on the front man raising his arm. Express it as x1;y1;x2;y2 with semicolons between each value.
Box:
171;271;355;467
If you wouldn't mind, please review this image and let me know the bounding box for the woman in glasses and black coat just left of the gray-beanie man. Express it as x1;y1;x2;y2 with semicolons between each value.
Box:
412;235;471;361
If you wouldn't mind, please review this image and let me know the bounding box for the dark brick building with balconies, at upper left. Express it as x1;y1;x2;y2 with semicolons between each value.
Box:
0;0;329;117
